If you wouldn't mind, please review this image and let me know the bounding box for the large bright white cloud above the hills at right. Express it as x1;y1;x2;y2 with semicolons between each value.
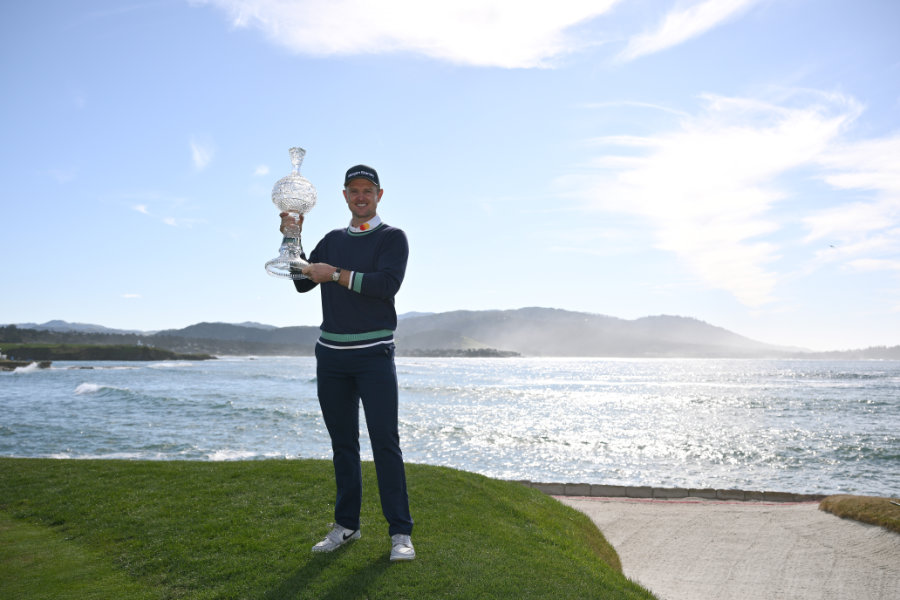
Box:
561;94;862;307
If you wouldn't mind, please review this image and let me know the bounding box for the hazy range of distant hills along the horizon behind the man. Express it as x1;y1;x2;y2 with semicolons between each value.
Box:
0;308;900;360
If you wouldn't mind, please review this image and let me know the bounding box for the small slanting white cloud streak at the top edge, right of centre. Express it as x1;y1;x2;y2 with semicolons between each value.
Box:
619;0;759;61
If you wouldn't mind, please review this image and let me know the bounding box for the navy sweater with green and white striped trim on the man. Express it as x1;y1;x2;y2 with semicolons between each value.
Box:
294;223;409;346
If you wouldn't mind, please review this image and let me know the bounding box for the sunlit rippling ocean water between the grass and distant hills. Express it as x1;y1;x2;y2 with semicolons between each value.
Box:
0;357;900;496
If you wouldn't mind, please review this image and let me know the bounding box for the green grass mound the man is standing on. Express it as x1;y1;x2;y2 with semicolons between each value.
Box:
0;458;653;600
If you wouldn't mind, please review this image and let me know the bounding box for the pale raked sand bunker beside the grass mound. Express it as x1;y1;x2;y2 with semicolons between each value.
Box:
556;496;900;600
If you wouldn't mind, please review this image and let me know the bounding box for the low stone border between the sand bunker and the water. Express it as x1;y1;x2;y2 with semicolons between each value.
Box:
518;481;827;502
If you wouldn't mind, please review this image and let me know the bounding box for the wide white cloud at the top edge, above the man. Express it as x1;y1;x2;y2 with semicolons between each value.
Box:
194;0;619;68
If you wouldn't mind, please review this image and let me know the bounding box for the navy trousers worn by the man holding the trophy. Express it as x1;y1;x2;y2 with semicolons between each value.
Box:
316;344;413;535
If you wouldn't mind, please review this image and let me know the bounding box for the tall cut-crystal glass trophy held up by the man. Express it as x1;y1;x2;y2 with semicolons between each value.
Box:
266;148;316;279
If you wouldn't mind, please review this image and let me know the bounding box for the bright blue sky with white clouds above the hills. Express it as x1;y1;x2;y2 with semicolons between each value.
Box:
0;0;900;350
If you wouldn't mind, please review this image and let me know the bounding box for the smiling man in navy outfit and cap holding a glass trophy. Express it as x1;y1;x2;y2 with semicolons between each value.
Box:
281;165;416;561
